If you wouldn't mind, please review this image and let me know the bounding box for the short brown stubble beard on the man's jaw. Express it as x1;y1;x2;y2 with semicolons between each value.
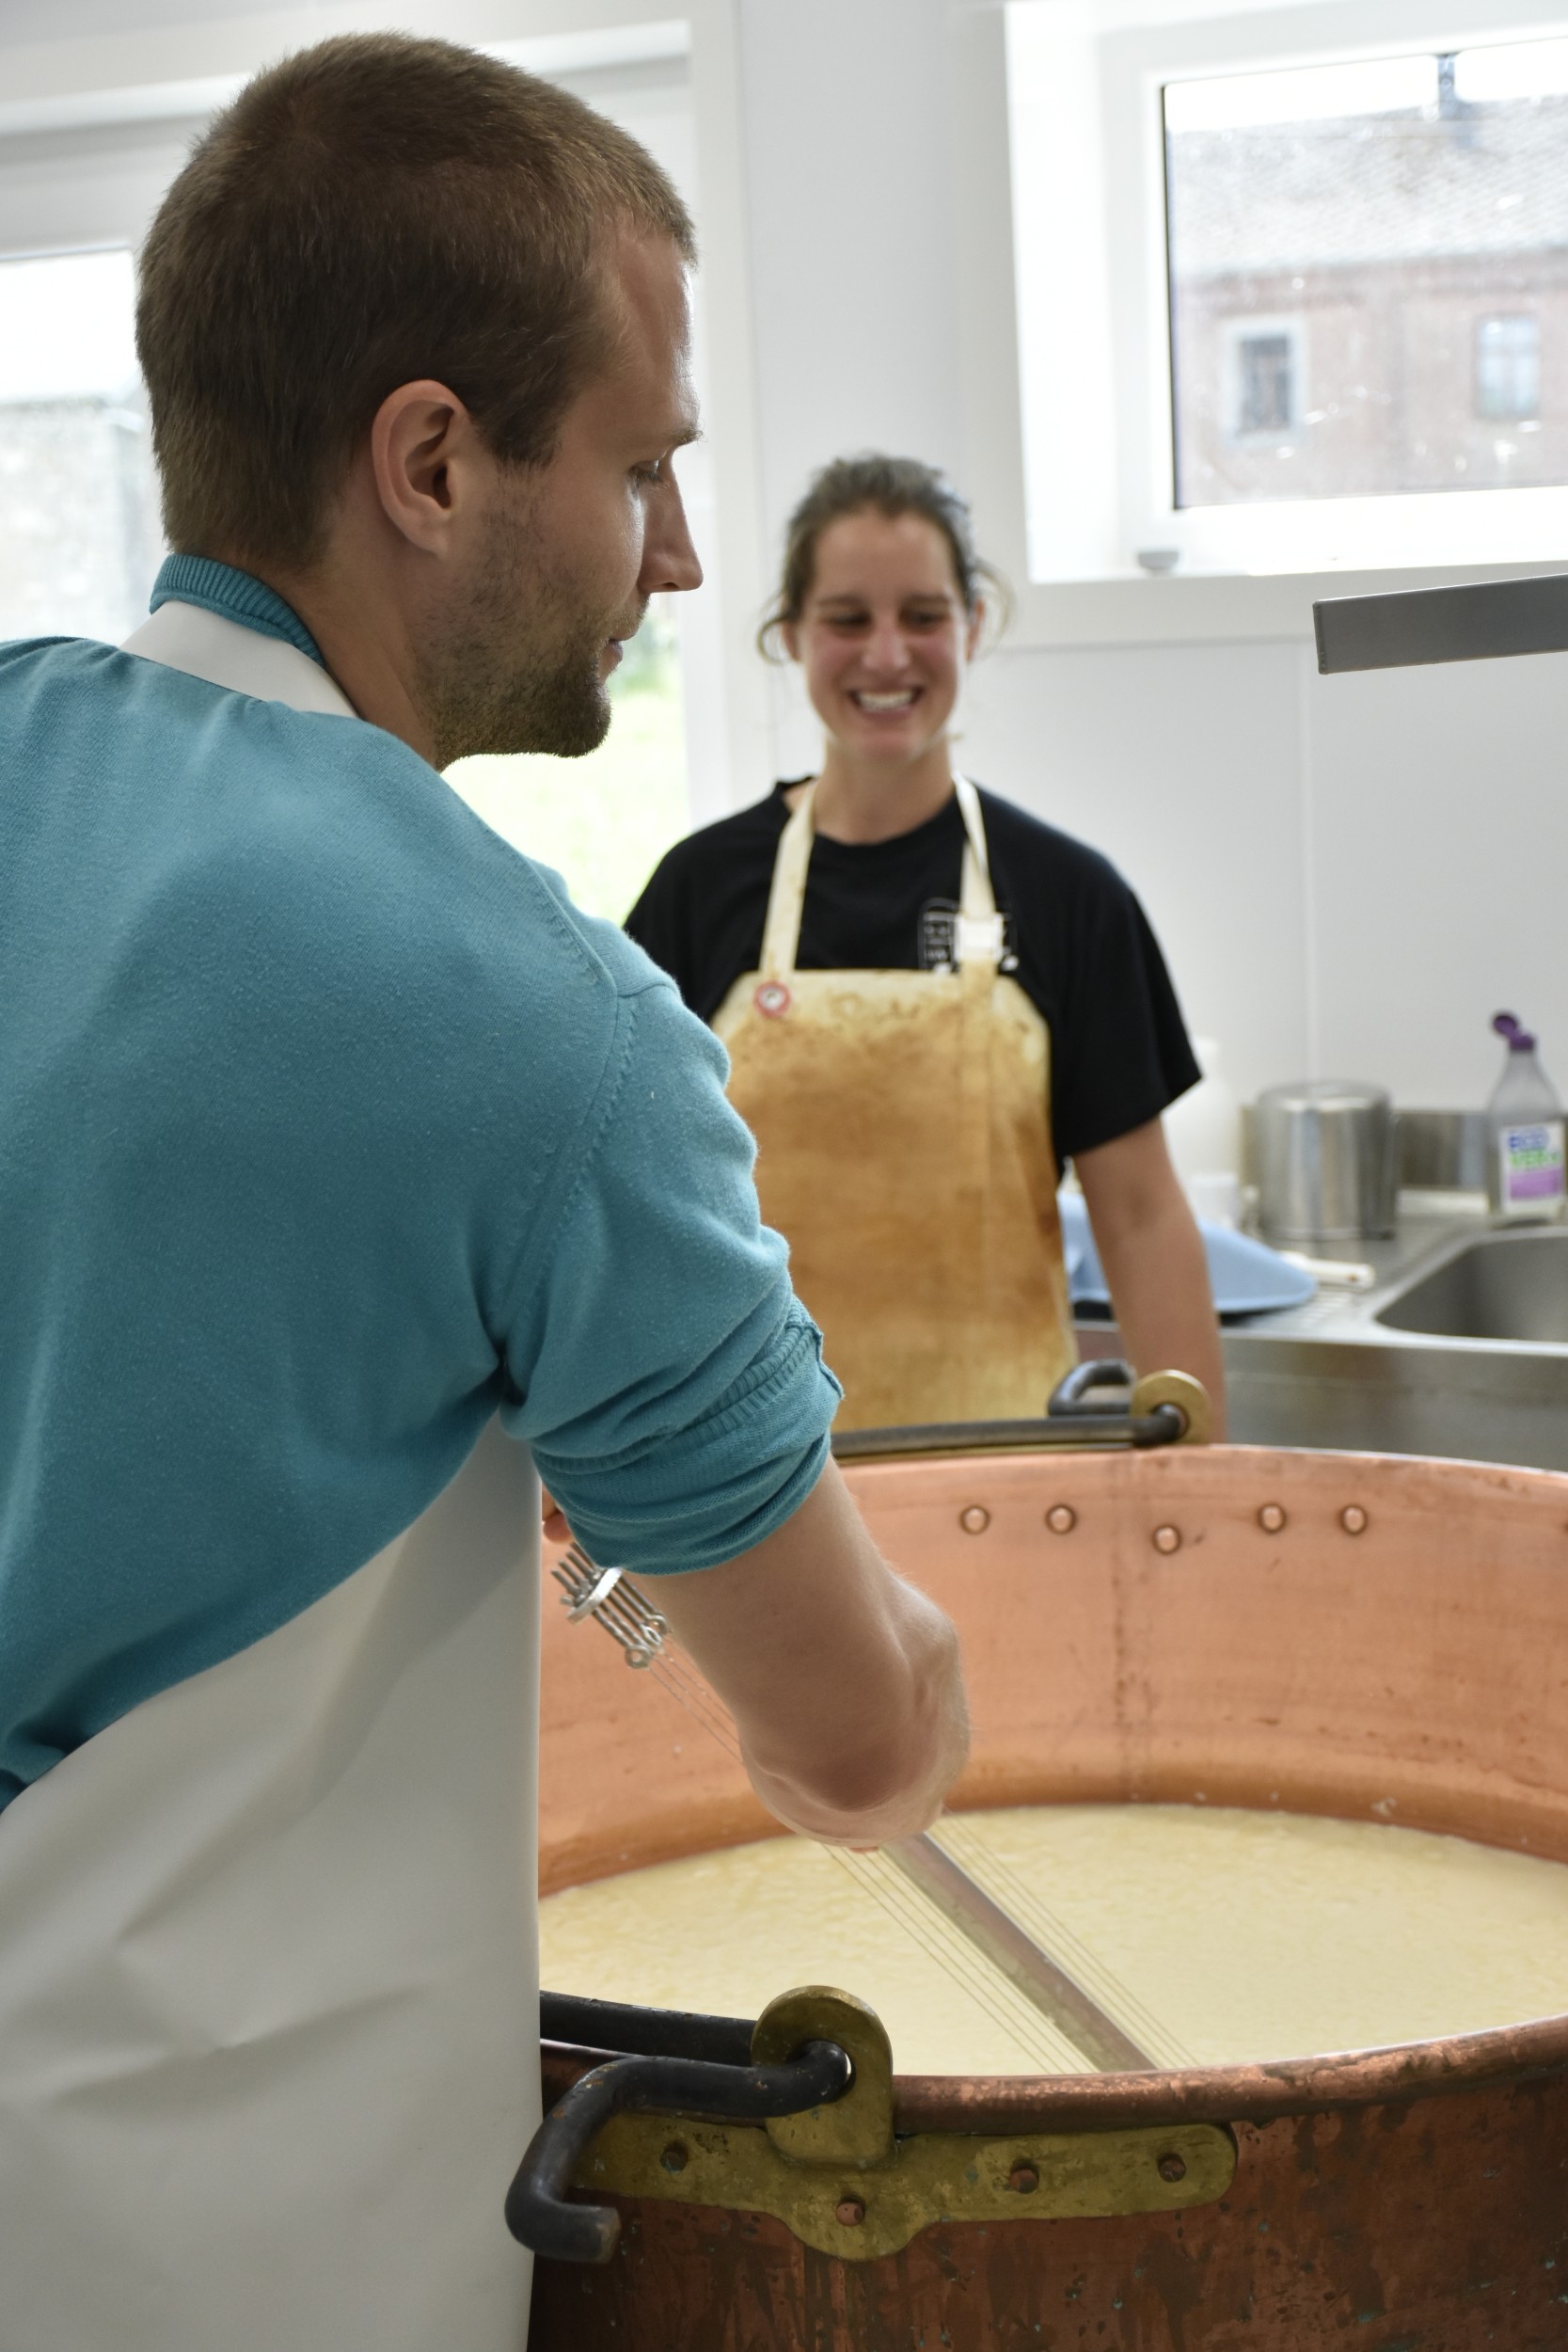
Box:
419;491;611;767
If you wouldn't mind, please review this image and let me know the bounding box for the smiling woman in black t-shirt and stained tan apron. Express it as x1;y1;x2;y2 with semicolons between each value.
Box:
627;454;1220;1428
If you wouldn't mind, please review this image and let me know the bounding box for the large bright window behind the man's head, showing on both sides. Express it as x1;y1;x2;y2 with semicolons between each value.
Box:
0;34;709;920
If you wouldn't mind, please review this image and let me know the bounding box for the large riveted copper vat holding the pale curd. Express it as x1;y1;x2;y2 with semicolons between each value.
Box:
531;1447;1568;2352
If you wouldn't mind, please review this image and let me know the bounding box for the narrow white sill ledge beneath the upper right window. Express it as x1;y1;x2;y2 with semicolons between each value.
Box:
1002;563;1568;652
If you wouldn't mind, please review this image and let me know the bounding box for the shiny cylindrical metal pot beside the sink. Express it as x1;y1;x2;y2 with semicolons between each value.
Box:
1253;1077;1399;1242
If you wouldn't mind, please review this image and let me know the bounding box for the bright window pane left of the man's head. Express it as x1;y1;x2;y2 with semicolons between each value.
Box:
0;252;162;643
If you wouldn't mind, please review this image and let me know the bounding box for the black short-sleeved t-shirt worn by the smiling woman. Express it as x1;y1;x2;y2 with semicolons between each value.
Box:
626;784;1199;1160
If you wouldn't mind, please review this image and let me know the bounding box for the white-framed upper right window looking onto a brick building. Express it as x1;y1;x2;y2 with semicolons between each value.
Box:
1006;0;1568;581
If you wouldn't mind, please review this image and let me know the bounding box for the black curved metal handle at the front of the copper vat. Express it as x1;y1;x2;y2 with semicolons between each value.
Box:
505;2004;853;2263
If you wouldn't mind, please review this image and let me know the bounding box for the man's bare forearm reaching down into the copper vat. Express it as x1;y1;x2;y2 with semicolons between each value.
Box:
643;1463;969;1847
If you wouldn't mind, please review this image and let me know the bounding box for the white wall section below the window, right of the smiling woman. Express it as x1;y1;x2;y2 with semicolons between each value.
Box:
964;644;1568;1108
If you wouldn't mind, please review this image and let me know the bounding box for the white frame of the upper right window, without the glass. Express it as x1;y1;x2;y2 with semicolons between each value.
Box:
1006;0;1568;643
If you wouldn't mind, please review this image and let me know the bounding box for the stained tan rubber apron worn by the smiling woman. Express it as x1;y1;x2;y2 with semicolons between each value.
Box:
715;779;1077;1430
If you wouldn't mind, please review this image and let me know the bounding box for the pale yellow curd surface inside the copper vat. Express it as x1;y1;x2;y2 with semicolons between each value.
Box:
541;1804;1568;2074
